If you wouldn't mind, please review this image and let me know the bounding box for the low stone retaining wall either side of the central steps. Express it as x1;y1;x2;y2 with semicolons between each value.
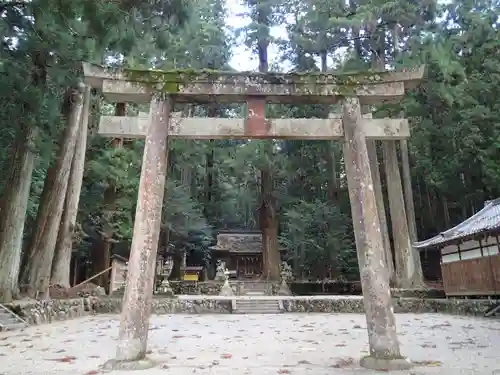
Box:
2;296;495;324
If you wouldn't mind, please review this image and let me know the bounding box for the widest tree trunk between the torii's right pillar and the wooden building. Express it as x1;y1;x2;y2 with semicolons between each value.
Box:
382;141;423;288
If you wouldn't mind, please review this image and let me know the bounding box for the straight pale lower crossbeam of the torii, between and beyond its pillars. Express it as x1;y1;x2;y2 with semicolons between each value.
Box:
99;113;410;140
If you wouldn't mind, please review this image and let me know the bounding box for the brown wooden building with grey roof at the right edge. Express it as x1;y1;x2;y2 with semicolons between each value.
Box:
414;198;500;296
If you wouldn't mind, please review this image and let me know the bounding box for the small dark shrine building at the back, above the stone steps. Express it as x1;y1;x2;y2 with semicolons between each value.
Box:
210;230;283;281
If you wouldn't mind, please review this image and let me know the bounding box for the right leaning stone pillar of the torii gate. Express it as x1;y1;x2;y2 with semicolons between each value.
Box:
343;98;410;370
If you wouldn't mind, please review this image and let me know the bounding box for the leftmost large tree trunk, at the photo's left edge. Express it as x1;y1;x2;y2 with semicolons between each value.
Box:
0;130;36;302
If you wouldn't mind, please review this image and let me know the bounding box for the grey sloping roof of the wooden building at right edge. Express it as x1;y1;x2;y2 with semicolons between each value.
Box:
413;198;500;249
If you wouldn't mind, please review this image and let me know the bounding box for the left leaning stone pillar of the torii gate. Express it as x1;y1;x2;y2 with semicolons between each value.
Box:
111;98;171;369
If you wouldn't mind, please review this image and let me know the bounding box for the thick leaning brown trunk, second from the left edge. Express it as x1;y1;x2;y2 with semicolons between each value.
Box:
23;85;85;297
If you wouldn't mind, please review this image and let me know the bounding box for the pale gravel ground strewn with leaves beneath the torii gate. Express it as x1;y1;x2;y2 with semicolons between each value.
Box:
0;314;500;375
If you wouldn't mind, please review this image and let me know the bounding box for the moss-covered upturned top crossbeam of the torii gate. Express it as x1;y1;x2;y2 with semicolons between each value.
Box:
83;63;424;104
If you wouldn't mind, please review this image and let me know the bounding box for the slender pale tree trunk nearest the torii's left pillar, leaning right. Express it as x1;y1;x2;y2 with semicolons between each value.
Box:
50;87;90;288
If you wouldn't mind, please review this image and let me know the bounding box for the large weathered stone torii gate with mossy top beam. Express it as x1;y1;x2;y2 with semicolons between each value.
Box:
84;64;424;369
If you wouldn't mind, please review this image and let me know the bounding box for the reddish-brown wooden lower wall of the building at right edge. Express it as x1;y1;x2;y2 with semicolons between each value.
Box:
441;254;500;296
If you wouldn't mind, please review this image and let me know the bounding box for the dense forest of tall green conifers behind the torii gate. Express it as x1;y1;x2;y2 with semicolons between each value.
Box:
0;0;500;301
